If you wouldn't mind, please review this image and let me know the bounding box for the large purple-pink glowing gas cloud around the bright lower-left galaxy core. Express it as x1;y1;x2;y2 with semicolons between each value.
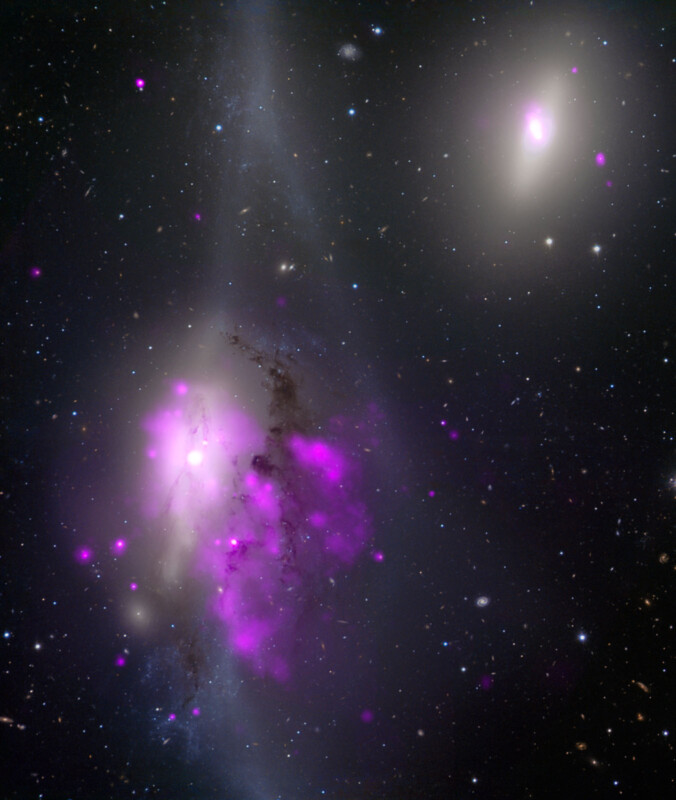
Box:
142;382;371;682
